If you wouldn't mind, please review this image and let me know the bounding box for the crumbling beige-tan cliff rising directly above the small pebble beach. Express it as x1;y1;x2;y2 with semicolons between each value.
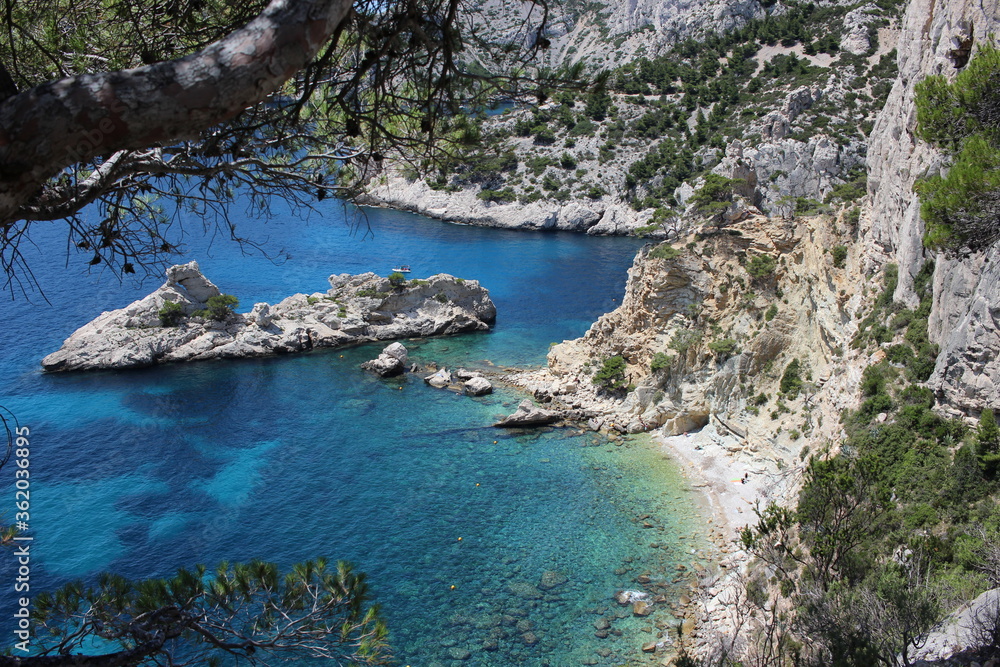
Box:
508;216;868;465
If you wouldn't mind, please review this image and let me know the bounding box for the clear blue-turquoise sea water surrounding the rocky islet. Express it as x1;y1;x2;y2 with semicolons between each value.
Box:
0;204;712;665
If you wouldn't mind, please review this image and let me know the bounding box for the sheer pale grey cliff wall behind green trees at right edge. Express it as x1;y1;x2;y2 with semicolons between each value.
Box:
861;0;1000;414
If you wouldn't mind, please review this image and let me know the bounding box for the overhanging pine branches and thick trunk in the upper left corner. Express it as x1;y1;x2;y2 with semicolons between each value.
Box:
0;0;564;284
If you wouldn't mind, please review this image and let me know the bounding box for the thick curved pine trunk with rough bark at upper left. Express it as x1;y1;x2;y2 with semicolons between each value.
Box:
0;0;351;229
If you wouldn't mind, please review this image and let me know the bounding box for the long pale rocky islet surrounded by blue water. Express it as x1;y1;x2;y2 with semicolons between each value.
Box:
42;262;496;371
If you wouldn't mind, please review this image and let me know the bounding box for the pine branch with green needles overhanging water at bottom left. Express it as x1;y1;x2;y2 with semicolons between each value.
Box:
10;559;391;666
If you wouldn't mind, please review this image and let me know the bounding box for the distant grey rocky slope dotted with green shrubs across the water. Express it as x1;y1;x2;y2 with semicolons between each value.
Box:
367;2;896;237
